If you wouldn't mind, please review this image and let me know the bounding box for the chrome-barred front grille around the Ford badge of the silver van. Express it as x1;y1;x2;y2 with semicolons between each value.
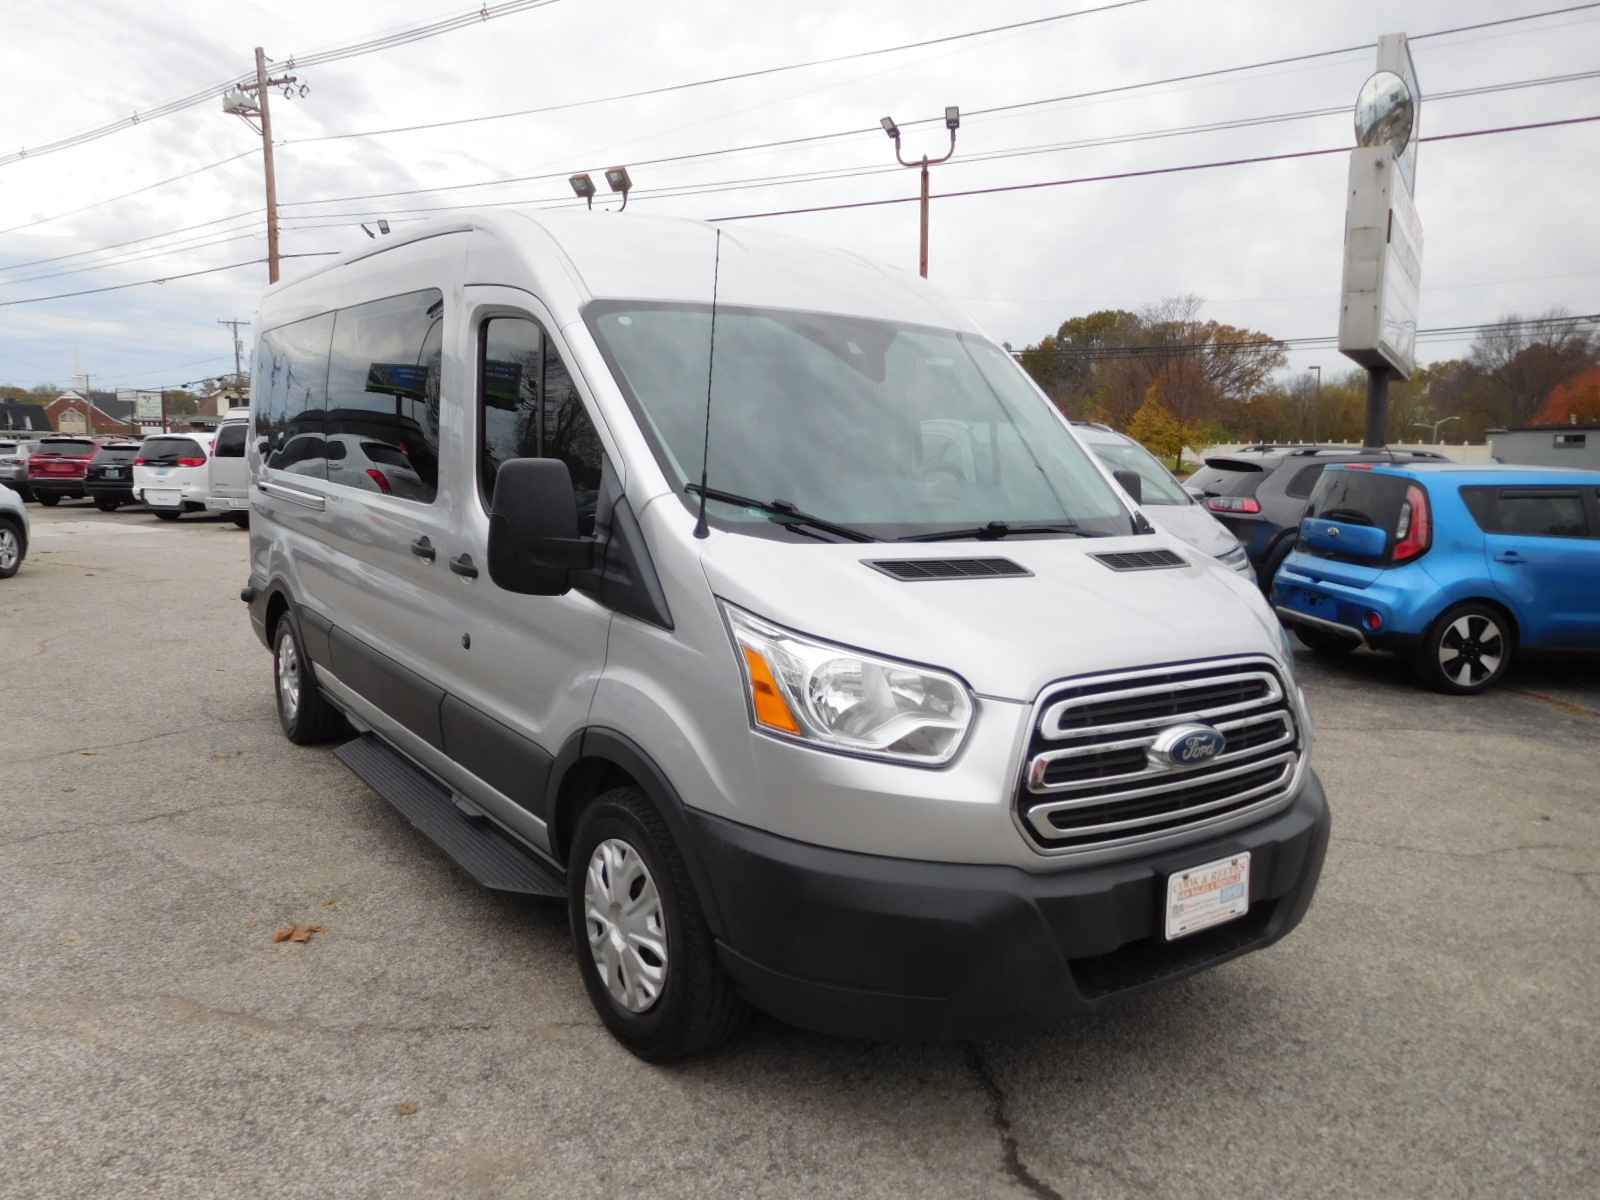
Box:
1016;658;1304;853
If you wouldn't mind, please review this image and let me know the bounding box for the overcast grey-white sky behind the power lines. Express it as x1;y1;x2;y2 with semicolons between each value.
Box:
0;0;1600;395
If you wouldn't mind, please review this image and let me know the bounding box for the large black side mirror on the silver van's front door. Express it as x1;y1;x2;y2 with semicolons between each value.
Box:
490;458;595;595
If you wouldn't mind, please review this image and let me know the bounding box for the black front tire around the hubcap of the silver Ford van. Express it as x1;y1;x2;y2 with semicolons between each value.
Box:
566;787;750;1062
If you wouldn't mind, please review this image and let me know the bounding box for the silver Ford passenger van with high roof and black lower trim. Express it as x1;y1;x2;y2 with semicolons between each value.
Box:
242;213;1330;1061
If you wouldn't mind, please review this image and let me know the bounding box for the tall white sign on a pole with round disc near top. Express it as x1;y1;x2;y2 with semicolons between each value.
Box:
1339;34;1422;450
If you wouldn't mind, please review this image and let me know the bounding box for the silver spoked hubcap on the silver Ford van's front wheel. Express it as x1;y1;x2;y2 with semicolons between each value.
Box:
584;838;667;1013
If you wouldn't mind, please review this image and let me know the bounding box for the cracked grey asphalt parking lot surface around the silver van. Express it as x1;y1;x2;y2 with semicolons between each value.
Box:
0;504;1600;1200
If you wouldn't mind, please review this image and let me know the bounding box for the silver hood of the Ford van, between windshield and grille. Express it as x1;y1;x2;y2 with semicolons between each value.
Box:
701;533;1285;702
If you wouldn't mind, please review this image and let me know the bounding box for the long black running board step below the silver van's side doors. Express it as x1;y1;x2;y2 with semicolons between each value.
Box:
334;733;566;899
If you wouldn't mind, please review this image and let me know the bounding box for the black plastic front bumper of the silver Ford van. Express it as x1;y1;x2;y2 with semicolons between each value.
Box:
686;773;1330;1040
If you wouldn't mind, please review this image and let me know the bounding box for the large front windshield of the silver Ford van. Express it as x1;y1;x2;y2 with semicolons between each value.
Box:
584;301;1133;539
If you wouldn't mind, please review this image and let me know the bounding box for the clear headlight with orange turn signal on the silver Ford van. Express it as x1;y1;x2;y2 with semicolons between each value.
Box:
722;603;973;766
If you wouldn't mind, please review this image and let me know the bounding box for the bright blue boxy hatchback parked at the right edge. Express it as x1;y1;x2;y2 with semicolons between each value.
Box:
1272;462;1600;694
